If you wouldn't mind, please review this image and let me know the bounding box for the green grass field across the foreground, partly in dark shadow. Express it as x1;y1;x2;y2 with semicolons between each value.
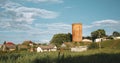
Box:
0;49;120;63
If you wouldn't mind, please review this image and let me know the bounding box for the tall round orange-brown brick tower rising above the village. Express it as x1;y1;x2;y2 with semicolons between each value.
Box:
72;23;82;42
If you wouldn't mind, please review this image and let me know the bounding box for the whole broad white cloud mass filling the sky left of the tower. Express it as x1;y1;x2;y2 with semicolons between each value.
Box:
0;0;62;42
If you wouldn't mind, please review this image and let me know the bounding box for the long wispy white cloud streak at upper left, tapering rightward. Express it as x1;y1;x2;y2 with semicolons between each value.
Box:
2;2;58;21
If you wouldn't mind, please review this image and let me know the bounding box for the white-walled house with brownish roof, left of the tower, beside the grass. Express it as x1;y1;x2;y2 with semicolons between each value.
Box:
37;45;57;52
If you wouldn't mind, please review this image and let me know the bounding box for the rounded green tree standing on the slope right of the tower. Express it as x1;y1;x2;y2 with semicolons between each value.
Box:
91;29;106;42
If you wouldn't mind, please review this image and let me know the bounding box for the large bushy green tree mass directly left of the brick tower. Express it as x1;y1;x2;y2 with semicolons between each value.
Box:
50;33;72;46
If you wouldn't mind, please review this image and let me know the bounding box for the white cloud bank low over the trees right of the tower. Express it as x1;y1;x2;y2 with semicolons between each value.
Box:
83;19;120;35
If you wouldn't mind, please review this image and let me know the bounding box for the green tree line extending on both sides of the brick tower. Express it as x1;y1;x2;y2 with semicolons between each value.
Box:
50;29;120;46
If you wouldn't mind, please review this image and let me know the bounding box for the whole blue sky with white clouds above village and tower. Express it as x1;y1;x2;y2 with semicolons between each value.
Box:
0;0;120;44
